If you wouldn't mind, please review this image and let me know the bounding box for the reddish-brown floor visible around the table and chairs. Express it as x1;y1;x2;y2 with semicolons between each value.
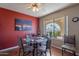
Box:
0;48;72;56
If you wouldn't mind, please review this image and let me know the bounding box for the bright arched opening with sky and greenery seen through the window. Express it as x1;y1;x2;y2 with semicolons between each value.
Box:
46;23;61;37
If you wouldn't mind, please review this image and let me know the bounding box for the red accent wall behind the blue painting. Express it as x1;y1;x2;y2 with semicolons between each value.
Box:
0;8;39;49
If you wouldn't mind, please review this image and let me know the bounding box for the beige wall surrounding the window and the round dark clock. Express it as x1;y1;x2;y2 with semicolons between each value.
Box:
40;4;79;53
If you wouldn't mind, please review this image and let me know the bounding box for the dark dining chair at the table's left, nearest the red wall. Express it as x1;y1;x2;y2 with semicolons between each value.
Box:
18;37;33;56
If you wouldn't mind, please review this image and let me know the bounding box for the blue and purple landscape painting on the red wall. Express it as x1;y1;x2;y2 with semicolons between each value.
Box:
15;18;32;31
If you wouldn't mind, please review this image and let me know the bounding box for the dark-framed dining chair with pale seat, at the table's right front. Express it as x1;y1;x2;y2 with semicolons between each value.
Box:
38;38;51;56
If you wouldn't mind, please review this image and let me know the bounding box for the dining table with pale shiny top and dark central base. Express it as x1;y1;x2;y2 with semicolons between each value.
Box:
24;37;45;56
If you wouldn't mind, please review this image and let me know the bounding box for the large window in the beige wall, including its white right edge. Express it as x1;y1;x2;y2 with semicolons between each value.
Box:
44;16;68;39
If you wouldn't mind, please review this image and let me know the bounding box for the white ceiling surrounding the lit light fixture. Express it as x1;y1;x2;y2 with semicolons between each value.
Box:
0;3;73;17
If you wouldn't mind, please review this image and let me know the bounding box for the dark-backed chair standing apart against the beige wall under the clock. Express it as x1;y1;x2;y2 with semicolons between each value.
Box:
62;35;76;56
